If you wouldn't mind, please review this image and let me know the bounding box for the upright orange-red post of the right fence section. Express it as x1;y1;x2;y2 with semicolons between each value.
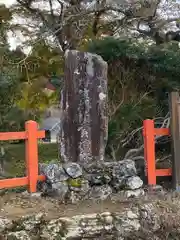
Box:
143;119;156;185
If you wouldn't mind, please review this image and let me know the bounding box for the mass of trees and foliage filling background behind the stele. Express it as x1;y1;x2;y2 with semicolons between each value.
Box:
0;0;180;160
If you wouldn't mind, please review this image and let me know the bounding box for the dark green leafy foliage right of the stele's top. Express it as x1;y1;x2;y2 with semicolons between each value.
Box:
88;37;180;81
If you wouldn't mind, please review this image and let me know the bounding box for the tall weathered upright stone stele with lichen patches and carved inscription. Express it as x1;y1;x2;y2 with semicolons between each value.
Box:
60;50;108;168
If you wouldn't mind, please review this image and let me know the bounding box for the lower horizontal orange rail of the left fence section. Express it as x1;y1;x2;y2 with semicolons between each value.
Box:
0;175;45;189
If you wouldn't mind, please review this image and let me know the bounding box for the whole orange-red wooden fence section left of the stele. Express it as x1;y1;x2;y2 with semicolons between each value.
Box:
0;121;45;193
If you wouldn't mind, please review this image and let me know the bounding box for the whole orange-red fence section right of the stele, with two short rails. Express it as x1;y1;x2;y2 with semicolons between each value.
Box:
143;119;172;185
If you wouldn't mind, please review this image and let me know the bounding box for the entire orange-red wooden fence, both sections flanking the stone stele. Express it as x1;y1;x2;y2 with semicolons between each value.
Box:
0;119;172;192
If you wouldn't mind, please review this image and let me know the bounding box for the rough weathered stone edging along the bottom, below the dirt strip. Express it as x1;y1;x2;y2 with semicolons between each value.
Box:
0;202;180;240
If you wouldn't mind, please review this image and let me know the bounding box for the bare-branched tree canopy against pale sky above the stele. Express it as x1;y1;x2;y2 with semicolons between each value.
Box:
8;0;180;51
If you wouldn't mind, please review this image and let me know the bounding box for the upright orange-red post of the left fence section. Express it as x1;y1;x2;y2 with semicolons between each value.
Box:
25;121;38;193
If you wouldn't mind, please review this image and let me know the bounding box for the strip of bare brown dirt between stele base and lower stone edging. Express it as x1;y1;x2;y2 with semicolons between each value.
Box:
0;188;174;219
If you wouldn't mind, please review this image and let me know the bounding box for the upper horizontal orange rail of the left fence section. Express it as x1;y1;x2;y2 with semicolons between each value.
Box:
0;131;45;141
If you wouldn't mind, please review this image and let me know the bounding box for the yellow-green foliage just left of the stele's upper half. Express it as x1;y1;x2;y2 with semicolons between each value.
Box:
15;40;63;116
